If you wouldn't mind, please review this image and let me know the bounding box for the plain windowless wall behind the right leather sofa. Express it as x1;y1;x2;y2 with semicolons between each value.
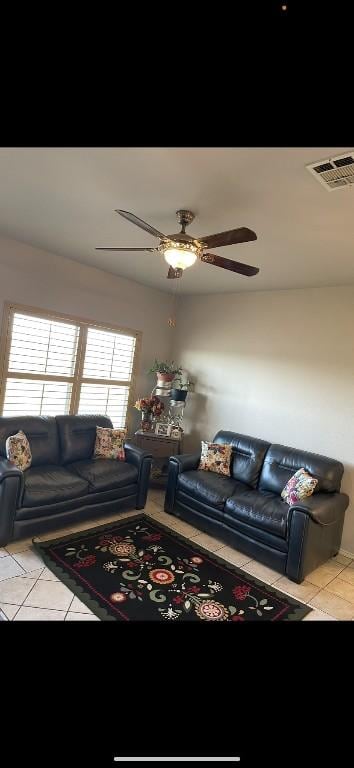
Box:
173;287;354;552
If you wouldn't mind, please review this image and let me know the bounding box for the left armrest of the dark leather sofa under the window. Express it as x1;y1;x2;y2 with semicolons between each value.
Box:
0;459;23;547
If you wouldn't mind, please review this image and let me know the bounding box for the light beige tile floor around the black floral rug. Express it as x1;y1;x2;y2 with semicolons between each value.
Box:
0;490;354;621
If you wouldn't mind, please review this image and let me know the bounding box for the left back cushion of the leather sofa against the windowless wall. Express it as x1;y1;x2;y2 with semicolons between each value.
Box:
213;430;272;488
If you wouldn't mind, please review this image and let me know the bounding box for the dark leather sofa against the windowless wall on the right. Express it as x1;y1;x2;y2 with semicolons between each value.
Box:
165;431;349;583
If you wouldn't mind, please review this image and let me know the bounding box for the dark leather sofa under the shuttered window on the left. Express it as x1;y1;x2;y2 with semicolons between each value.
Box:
0;416;152;547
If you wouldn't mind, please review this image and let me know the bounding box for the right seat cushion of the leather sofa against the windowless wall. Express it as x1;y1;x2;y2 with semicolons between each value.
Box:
224;489;289;539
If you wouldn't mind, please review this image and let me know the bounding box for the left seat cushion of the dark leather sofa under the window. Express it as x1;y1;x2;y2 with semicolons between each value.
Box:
21;464;89;507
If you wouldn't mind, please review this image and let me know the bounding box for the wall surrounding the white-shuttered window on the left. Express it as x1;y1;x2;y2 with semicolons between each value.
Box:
0;239;173;432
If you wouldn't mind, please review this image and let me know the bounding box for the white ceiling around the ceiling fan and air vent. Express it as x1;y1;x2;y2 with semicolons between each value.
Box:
0;147;354;294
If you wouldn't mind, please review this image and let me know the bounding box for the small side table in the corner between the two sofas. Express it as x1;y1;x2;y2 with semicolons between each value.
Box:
134;429;183;488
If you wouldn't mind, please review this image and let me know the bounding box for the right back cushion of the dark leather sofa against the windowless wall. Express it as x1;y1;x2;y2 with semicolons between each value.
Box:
259;445;344;494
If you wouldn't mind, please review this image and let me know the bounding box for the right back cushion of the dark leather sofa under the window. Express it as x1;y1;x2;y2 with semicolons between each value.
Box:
55;416;113;464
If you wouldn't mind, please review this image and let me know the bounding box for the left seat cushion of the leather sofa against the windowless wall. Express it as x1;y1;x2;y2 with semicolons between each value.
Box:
177;469;242;509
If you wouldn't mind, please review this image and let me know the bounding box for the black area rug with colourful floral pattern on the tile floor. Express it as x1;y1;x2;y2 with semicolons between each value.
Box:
33;514;311;622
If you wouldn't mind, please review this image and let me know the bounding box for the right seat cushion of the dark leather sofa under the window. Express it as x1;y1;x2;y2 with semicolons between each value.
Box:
67;459;138;493
